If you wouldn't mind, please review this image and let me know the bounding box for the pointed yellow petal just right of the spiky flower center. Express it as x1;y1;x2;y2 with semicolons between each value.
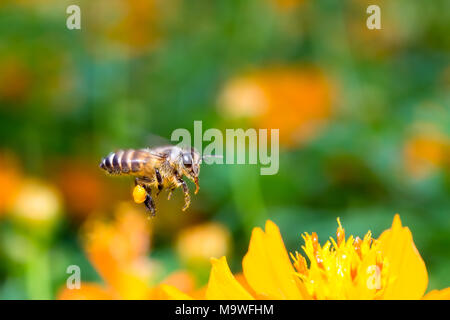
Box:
379;214;428;299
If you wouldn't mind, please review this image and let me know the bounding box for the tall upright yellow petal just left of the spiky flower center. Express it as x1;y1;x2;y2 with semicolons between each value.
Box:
242;220;304;299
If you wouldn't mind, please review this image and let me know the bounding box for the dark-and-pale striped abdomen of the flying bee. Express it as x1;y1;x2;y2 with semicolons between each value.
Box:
100;150;146;174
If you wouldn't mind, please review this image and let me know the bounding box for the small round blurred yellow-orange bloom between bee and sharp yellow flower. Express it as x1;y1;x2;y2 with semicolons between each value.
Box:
177;222;230;262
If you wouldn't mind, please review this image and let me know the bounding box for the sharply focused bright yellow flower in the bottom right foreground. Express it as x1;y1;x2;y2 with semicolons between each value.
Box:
168;215;450;299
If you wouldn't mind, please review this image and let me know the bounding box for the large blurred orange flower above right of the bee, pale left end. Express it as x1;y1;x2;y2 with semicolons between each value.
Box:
219;67;333;147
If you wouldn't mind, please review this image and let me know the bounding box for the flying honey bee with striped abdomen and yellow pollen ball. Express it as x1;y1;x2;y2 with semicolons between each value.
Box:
100;146;202;216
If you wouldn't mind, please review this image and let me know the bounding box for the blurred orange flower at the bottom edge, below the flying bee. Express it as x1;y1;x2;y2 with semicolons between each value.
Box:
58;203;194;299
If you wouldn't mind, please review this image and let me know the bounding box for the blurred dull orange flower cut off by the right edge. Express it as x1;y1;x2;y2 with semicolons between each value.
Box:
404;130;450;178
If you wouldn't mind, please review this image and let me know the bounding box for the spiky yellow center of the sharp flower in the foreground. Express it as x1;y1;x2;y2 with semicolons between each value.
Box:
291;218;393;299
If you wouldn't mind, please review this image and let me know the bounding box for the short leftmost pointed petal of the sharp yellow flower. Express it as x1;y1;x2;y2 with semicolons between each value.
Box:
206;257;253;300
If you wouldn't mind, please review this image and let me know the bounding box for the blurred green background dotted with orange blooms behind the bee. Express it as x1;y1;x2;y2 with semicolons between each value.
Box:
0;0;450;299
